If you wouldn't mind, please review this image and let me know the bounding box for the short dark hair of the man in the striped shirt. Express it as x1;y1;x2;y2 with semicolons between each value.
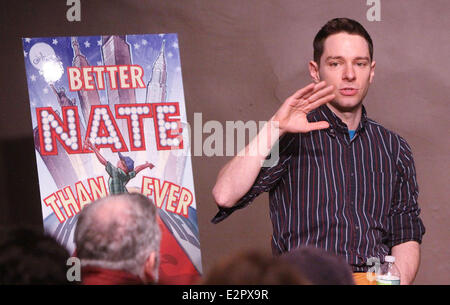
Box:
313;18;373;65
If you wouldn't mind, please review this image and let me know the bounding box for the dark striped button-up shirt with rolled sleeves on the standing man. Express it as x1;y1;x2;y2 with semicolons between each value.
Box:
212;105;425;272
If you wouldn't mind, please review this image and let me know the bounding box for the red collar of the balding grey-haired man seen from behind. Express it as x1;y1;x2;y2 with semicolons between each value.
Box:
81;266;144;285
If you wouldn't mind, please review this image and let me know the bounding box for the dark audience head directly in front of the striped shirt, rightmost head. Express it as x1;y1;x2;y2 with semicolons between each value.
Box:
280;246;354;285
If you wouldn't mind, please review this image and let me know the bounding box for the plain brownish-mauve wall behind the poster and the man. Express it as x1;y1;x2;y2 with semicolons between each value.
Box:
0;0;450;284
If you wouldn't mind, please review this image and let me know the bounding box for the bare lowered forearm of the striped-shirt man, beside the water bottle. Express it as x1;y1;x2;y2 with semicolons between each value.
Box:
391;241;420;285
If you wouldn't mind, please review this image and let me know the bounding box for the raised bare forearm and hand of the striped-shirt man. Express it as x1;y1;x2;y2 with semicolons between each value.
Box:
213;82;334;207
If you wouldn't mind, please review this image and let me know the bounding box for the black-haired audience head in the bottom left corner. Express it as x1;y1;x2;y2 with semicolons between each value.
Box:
0;224;70;285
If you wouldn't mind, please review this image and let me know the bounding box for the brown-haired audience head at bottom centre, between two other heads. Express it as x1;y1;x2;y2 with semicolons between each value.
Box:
200;250;309;285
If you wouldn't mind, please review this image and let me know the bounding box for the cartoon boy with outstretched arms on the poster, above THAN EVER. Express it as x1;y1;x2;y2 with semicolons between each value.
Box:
85;139;155;195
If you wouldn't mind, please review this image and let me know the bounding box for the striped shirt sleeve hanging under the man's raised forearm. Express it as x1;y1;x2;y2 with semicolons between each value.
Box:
211;134;299;223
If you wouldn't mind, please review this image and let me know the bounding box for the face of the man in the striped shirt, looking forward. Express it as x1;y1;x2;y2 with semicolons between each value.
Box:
311;33;375;112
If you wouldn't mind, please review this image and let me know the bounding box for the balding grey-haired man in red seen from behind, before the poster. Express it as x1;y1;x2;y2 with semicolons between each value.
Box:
75;193;161;285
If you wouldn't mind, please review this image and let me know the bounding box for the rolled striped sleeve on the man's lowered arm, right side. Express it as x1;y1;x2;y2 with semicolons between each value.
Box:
388;137;425;247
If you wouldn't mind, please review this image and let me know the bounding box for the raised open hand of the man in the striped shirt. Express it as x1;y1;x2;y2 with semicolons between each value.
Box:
271;82;335;135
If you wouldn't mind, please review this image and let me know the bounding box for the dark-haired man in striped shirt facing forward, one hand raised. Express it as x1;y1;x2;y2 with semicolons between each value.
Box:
213;18;425;284
